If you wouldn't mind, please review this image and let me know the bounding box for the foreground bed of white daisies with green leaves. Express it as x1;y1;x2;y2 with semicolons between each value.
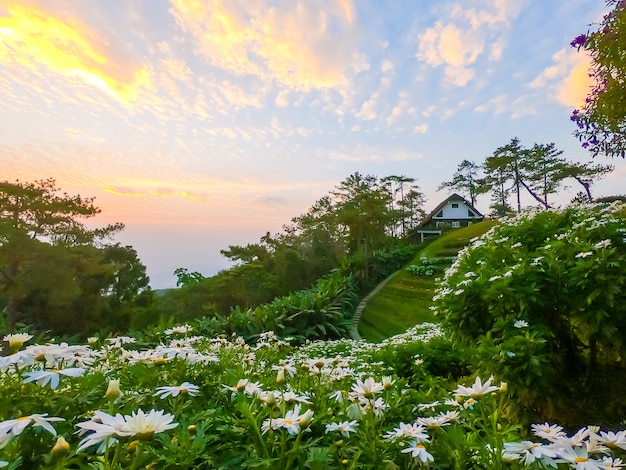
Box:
0;324;624;470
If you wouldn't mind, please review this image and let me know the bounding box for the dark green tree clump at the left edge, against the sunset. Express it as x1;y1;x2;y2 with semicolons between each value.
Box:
0;179;150;334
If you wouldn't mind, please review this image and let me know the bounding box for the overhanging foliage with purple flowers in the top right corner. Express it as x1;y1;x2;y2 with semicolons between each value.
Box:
571;0;626;158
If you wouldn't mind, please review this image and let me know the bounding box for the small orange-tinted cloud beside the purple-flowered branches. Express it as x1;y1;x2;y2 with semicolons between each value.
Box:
528;49;592;108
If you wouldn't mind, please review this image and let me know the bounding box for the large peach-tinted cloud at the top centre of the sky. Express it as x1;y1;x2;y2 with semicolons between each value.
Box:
170;0;367;91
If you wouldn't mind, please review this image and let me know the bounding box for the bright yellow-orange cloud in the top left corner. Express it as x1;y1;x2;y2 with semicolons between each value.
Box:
0;4;151;103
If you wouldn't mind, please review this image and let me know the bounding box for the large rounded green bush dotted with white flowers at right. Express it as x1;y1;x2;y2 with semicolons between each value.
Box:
435;202;626;426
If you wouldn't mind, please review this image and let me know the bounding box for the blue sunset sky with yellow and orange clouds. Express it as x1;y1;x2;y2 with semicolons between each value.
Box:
0;0;626;288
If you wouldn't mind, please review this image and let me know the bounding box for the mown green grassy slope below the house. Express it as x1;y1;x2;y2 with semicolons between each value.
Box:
359;220;496;342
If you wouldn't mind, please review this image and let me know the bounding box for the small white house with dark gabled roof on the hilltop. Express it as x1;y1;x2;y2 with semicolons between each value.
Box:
415;193;484;242
